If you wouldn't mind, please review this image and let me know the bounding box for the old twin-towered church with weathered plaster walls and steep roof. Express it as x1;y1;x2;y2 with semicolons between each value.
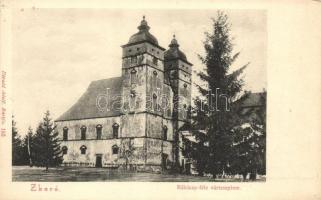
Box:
55;17;192;171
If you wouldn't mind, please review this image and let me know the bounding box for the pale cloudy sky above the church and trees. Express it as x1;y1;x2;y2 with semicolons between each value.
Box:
12;8;267;134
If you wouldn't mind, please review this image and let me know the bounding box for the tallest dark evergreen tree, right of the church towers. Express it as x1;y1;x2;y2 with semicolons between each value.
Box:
193;11;247;178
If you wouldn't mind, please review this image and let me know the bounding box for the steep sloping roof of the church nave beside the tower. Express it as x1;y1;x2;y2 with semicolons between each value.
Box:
55;77;122;121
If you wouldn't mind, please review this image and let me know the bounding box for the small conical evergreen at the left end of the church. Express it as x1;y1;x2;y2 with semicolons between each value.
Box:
33;111;62;171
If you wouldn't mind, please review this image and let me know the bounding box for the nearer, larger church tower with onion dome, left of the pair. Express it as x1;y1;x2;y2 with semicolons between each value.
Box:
120;17;173;170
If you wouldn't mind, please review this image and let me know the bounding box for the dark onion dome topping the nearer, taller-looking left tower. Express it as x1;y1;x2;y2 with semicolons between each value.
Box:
128;16;158;45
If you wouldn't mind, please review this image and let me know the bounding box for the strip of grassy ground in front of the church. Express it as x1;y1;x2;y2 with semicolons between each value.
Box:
12;166;265;182
